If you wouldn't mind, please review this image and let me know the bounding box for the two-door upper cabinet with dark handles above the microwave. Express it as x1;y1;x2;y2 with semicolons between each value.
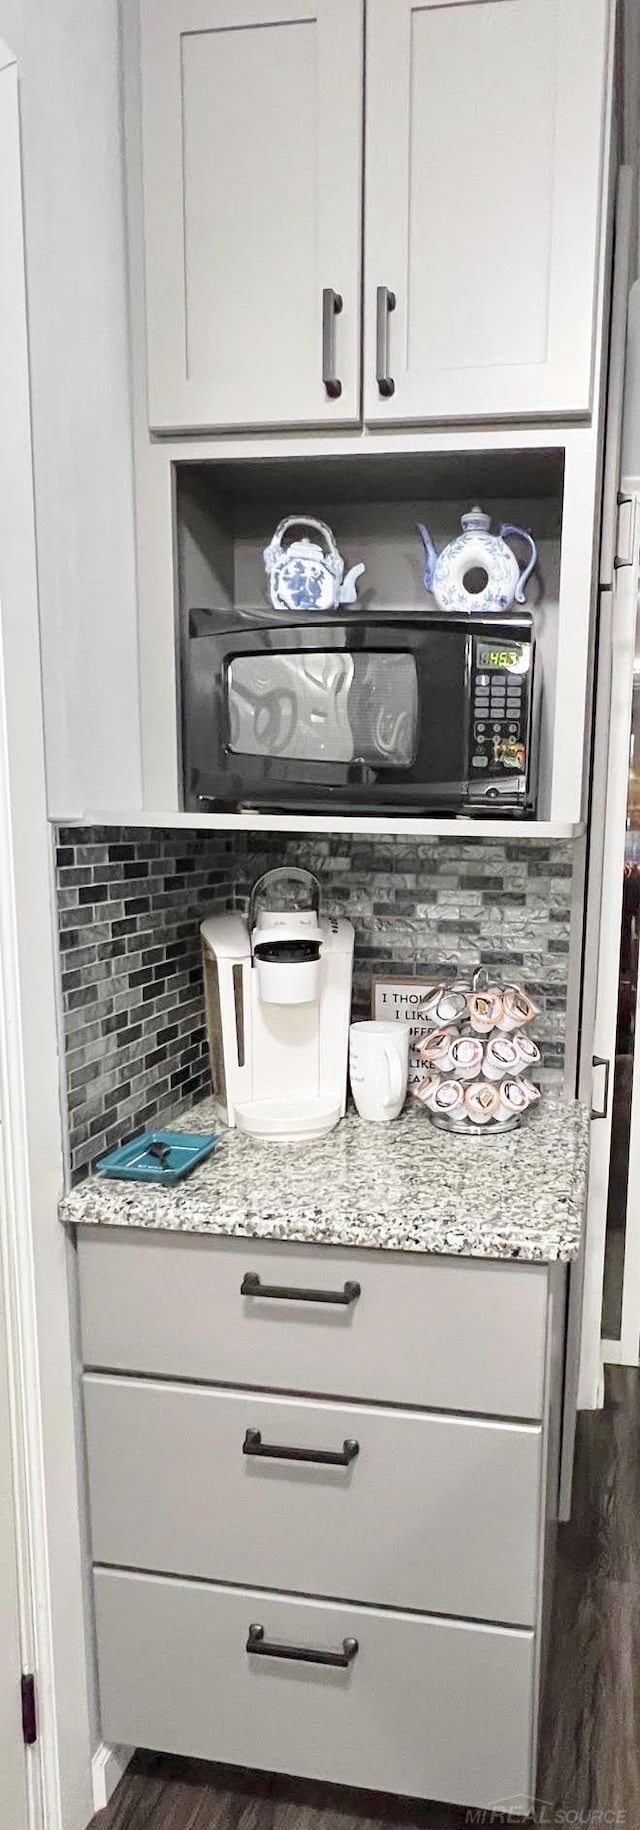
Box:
133;0;611;432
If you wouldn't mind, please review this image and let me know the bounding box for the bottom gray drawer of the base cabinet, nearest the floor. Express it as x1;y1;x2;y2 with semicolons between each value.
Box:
95;1568;534;1808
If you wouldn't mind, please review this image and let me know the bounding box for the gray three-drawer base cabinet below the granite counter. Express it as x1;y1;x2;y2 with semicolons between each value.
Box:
79;1226;563;1810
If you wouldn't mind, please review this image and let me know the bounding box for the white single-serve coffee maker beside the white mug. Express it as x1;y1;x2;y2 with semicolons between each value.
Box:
199;869;353;1140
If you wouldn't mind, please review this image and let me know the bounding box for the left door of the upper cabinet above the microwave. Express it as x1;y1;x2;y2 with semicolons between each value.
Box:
141;0;362;430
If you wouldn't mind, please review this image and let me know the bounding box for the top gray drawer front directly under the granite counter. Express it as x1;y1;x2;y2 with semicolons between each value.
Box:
79;1228;547;1418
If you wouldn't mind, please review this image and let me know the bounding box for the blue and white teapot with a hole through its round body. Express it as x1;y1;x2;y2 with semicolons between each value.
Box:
417;509;538;615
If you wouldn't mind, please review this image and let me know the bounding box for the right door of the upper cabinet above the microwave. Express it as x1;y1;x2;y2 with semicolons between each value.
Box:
364;0;609;425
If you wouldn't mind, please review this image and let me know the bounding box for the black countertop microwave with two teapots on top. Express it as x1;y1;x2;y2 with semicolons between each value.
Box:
183;609;538;816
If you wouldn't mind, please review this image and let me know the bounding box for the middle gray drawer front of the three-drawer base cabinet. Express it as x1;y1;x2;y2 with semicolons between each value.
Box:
84;1374;541;1625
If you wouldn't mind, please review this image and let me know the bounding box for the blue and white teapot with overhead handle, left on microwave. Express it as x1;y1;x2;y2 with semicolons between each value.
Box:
265;514;364;609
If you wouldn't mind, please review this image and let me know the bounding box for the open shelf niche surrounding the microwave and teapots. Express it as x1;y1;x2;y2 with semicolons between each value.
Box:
176;447;563;836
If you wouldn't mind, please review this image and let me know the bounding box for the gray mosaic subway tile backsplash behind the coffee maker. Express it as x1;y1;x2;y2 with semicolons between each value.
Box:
57;827;572;1180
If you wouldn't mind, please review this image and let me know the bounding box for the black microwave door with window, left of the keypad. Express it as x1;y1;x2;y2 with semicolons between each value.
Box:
185;617;470;813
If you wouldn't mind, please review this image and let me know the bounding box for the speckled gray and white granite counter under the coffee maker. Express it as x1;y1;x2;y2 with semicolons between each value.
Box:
60;1098;589;1263
